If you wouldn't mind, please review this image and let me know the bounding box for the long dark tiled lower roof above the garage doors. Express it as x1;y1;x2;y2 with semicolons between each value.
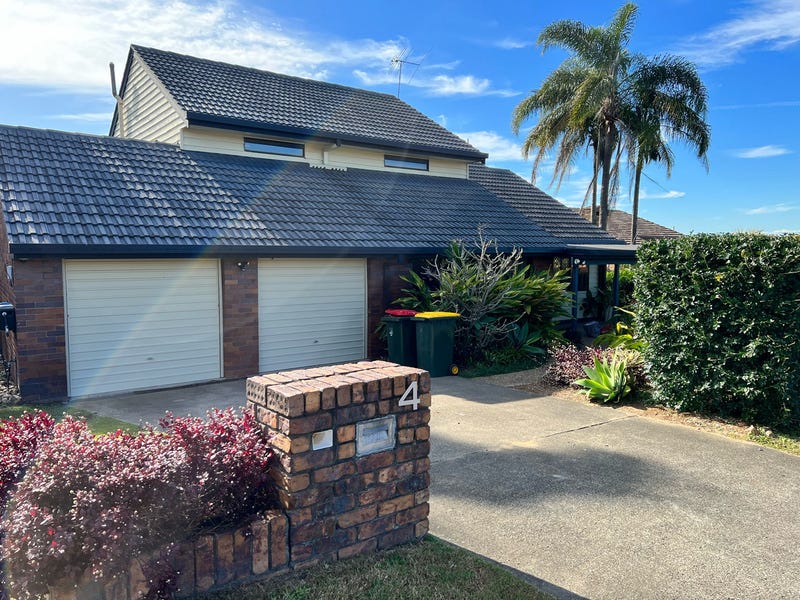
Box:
0;126;564;255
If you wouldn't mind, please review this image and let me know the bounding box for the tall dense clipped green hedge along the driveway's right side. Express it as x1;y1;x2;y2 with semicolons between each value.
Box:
634;233;800;427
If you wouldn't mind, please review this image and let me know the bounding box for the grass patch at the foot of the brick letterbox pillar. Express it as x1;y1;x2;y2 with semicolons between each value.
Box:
202;535;552;600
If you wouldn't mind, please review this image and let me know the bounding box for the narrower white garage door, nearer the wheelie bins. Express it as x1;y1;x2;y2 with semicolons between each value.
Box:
258;258;367;372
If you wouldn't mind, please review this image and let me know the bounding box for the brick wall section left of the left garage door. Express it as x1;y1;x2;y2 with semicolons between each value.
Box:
14;258;67;402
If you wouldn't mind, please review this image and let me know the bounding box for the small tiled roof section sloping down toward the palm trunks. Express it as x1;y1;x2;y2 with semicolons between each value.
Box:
469;164;617;244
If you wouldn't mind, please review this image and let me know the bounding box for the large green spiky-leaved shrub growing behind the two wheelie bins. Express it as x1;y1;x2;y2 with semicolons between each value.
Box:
395;237;567;364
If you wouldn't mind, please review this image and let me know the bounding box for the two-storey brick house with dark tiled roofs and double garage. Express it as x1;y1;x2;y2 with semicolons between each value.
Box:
0;46;632;401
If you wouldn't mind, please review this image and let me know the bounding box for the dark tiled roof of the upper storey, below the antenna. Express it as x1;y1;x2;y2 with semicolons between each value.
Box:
131;46;486;159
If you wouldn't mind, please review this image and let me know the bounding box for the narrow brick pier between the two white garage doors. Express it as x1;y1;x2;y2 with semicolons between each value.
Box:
222;259;258;378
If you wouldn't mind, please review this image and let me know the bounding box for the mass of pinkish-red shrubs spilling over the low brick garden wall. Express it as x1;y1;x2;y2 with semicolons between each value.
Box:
3;410;270;598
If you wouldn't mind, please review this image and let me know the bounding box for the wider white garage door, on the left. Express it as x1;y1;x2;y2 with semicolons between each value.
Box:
64;259;221;397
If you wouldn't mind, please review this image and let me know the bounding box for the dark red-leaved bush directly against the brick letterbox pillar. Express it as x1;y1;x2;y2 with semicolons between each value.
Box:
159;408;274;525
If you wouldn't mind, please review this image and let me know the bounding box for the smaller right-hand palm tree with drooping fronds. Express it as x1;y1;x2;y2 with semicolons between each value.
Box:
624;55;711;244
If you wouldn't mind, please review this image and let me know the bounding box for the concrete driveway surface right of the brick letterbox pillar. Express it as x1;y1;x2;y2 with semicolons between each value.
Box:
430;377;800;599
